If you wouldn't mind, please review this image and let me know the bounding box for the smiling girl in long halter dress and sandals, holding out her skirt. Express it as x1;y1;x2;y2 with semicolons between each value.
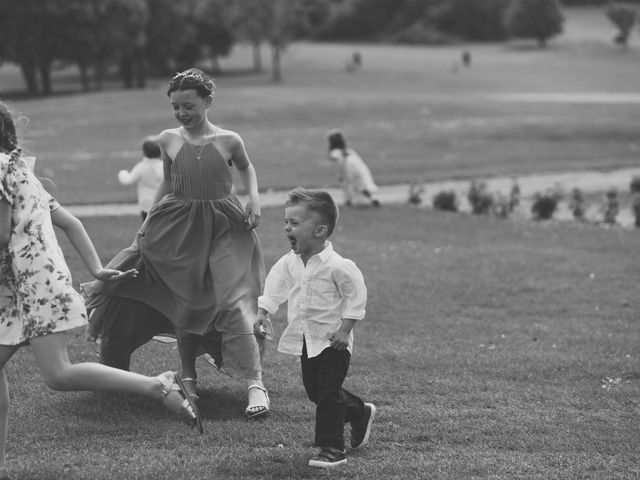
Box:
83;68;269;418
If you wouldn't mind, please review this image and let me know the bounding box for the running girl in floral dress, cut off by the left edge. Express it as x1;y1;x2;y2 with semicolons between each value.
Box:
0;103;201;479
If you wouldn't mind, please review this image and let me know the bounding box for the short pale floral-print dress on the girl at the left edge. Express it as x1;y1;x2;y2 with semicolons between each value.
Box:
0;150;87;345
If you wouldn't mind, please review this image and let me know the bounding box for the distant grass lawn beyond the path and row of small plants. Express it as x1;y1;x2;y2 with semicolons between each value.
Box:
0;9;640;203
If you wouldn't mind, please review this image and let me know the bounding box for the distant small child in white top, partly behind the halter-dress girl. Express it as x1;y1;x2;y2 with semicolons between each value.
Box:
118;137;164;220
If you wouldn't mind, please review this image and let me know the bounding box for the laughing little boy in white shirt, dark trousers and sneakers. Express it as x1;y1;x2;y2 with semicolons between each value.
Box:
254;188;376;468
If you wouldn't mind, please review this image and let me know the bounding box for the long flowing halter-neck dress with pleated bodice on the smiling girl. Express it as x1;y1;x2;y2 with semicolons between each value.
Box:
83;137;265;378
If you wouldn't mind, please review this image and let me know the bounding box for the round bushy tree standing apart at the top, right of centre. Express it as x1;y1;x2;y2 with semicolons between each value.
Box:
505;0;564;48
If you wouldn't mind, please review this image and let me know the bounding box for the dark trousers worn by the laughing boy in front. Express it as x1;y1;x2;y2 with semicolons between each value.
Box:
300;341;365;450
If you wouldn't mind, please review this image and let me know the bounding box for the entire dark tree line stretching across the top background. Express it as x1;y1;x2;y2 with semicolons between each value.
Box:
0;0;640;94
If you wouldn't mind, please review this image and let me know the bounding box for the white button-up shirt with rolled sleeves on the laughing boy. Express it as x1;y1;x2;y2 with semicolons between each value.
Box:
258;242;367;358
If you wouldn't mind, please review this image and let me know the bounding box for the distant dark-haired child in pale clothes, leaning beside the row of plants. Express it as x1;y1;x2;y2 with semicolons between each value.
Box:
327;130;380;207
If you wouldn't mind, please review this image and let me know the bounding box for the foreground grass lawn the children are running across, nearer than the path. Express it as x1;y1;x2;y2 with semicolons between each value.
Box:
2;207;640;480
